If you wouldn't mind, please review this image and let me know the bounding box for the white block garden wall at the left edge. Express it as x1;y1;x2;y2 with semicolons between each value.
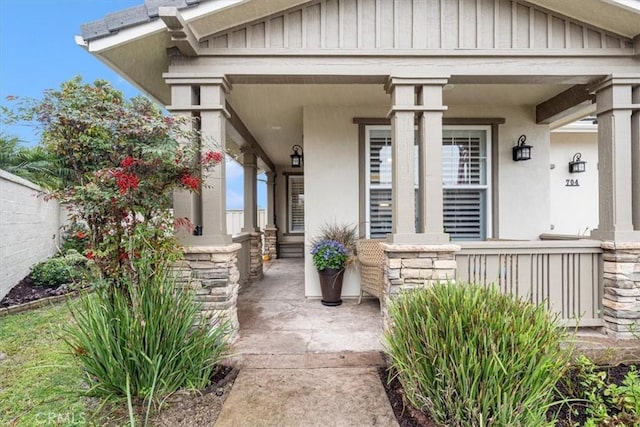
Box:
0;170;60;299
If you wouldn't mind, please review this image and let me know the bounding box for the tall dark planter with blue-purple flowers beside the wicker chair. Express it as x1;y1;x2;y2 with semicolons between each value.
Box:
311;239;349;307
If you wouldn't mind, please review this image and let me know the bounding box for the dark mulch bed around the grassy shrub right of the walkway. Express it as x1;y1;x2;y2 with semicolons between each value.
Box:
378;365;640;427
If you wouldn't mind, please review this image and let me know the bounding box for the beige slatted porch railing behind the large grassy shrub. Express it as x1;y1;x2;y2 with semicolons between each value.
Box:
456;240;603;327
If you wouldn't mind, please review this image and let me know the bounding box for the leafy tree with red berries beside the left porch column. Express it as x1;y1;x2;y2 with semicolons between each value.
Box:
7;77;223;284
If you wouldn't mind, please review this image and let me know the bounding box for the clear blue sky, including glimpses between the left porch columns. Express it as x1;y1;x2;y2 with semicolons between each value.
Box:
0;0;266;209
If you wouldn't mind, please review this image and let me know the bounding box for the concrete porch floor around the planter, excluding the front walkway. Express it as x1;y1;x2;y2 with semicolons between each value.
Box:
234;259;383;356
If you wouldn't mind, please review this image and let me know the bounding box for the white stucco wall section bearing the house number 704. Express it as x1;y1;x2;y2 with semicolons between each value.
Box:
550;131;598;235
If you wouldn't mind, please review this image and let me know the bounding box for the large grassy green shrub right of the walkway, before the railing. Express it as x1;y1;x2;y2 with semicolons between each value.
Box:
386;284;569;426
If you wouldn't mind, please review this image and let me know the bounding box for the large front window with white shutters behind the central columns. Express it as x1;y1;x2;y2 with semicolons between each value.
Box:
365;125;491;240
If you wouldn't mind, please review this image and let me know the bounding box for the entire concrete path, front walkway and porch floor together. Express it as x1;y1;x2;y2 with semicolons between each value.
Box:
216;259;398;427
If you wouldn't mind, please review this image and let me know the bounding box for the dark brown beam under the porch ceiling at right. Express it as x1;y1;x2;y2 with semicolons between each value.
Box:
536;85;596;124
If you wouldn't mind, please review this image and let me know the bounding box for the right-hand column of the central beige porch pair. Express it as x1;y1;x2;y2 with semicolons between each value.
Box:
418;78;449;243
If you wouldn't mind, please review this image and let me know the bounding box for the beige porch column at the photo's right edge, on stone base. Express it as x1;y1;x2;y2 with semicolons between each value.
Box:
592;76;640;242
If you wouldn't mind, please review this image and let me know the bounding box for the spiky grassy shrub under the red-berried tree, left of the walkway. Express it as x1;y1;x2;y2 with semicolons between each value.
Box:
66;256;228;402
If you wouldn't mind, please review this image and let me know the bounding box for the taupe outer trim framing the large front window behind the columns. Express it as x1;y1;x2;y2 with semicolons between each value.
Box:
362;123;498;239
